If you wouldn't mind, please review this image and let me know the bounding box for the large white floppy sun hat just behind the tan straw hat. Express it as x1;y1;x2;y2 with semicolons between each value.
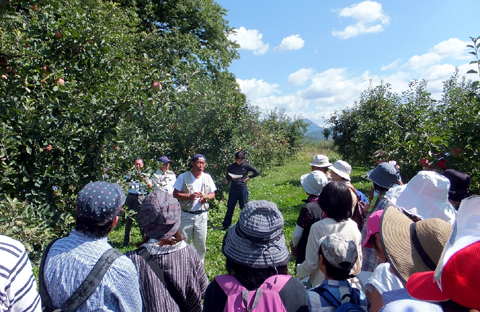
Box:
386;170;457;224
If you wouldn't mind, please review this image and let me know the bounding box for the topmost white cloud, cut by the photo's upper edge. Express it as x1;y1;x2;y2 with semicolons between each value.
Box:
332;1;390;39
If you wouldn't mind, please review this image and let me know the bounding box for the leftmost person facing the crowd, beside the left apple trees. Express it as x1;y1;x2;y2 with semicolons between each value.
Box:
123;158;153;246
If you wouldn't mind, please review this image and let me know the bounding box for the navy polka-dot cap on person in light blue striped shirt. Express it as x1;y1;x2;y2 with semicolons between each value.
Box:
77;181;125;226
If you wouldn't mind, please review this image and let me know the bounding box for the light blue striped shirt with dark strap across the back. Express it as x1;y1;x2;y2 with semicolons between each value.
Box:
44;230;142;311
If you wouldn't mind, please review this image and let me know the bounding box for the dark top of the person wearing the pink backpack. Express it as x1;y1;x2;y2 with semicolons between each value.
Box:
203;277;309;312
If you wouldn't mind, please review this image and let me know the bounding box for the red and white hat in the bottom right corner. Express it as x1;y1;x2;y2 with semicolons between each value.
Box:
407;196;480;310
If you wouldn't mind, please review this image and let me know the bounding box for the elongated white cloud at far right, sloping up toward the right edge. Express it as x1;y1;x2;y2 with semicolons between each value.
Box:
405;38;470;70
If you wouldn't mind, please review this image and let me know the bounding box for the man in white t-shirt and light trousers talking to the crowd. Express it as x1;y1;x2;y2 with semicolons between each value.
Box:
173;154;217;261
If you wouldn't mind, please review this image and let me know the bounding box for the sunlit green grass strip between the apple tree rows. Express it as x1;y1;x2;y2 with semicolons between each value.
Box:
109;147;370;279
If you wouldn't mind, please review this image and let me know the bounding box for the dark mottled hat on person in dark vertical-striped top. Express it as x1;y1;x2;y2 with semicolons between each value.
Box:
137;190;181;240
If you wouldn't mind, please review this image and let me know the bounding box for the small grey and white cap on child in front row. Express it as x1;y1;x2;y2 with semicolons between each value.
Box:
318;233;358;271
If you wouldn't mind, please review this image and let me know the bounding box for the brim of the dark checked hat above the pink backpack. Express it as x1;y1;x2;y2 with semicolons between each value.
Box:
222;224;290;268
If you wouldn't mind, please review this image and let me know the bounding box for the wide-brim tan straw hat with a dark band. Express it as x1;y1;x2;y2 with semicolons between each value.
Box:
380;206;452;283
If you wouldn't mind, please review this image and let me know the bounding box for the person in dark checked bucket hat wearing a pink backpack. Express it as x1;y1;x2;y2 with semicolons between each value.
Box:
203;200;309;312
